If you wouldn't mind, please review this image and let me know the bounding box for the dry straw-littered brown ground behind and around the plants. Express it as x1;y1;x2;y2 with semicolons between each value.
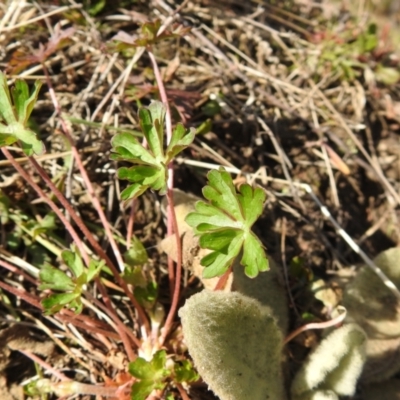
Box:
0;0;400;399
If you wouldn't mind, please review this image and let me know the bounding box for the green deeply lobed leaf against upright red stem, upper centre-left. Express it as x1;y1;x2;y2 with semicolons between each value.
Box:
111;101;195;200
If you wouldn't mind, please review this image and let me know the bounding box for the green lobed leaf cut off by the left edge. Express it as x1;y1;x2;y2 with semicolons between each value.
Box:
0;72;44;155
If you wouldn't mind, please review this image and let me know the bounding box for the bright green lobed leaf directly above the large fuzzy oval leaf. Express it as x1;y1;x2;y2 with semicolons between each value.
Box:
186;169;268;278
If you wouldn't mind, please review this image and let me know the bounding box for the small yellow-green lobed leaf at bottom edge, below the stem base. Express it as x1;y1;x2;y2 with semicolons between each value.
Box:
129;350;171;400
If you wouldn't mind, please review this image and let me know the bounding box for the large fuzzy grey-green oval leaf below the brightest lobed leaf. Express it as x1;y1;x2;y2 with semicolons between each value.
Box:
179;291;285;400
